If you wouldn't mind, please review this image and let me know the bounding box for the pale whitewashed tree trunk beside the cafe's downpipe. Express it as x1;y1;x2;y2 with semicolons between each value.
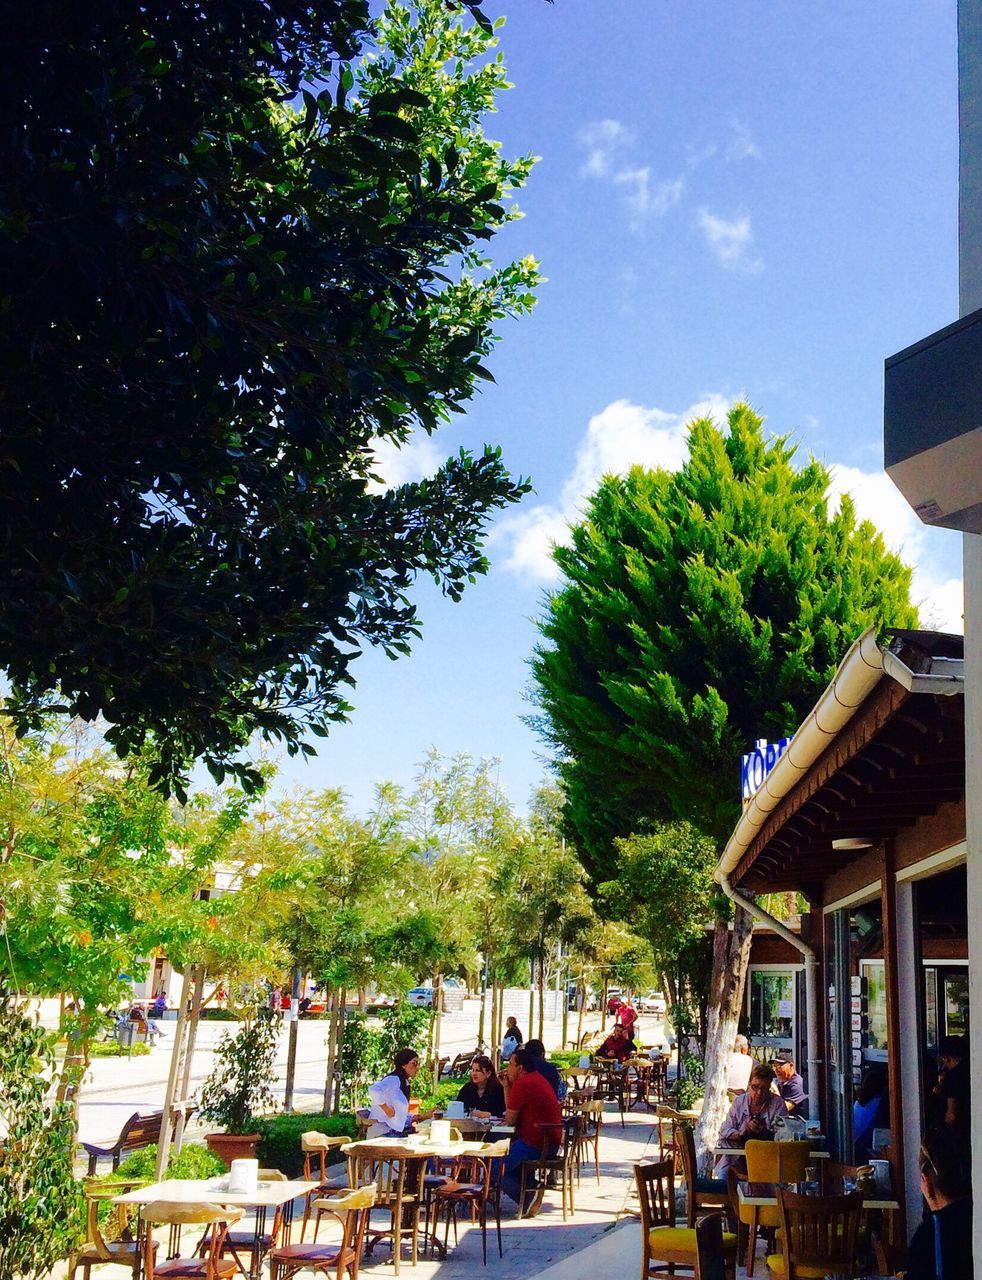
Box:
695;906;754;1172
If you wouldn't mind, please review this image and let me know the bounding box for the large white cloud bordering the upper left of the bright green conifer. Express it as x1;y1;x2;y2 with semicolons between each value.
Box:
492;394;730;584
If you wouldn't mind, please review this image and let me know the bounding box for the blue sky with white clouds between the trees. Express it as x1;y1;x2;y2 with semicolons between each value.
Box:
266;0;960;810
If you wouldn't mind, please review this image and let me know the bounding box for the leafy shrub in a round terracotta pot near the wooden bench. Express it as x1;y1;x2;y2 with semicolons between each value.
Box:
198;1014;279;1167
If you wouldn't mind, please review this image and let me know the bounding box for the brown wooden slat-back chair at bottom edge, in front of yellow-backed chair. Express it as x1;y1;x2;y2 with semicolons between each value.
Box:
767;1182;863;1280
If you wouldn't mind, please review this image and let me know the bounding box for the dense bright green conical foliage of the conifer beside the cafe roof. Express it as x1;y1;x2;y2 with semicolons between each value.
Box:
533;404;917;881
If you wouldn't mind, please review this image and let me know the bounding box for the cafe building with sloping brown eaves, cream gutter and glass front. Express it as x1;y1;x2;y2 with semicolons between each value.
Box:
717;631;969;1226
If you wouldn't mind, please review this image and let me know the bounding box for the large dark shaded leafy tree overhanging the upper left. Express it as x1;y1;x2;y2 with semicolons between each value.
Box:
0;0;536;790
